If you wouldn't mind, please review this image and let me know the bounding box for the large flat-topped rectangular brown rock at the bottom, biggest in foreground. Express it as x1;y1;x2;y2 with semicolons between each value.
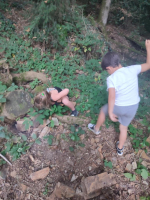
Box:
81;172;116;199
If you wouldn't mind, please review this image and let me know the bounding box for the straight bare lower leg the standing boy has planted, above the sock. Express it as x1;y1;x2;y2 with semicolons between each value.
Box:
118;124;128;149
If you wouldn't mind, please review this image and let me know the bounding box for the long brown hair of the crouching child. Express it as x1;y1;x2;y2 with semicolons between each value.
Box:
34;91;52;109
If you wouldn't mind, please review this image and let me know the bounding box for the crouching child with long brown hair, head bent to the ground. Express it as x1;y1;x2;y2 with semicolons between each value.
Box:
34;87;78;117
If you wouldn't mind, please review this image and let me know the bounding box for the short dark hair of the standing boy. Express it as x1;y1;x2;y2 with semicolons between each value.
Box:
101;52;120;70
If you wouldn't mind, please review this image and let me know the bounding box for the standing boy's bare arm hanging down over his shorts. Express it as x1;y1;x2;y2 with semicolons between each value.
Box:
108;88;118;122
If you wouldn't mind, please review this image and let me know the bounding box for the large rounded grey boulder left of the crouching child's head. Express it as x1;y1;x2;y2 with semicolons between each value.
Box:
1;90;33;120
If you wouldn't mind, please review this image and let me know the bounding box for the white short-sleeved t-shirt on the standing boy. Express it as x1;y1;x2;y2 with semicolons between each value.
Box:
107;65;141;106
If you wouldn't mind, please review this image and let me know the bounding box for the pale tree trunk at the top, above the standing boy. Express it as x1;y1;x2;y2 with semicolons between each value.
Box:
98;0;111;26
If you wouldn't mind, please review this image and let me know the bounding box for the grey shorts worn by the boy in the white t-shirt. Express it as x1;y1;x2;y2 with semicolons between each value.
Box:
101;103;139;126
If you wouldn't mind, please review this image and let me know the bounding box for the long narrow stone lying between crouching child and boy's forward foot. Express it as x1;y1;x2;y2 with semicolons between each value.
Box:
54;114;90;126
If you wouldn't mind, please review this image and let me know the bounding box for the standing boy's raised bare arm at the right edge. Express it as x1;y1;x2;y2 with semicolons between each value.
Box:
141;40;150;72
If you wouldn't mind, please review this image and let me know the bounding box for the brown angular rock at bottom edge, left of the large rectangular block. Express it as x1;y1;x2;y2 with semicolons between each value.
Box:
48;182;75;200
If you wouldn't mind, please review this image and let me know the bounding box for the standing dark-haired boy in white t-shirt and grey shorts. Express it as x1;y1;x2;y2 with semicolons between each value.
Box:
88;40;150;156
